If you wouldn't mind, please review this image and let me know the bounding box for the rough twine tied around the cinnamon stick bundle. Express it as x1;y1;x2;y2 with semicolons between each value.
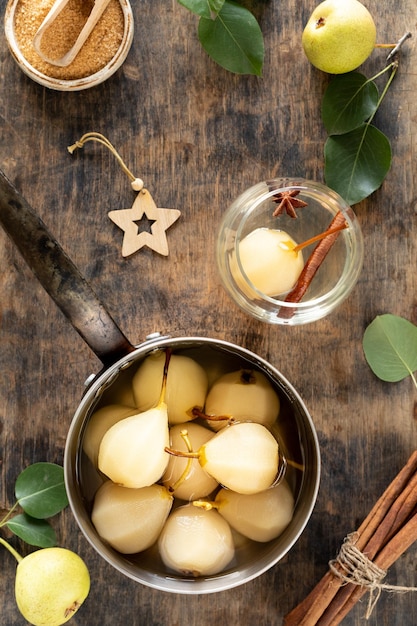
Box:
329;533;417;619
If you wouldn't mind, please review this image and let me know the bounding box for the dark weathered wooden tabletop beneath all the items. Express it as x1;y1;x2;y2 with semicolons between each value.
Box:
0;0;417;626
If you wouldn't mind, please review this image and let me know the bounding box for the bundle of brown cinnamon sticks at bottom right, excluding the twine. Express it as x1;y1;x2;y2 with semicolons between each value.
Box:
284;450;417;626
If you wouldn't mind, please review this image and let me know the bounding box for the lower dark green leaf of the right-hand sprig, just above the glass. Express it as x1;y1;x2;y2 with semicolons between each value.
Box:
324;124;391;204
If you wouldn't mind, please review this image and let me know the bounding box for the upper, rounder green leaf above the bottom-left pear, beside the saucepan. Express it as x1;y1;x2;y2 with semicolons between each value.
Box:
15;463;68;519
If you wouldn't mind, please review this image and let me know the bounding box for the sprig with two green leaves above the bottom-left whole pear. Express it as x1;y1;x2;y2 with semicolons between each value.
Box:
0;463;68;549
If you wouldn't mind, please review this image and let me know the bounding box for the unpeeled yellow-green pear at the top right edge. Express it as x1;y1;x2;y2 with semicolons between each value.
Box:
302;0;376;74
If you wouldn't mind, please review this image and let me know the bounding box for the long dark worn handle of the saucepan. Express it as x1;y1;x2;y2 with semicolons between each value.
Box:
0;171;135;366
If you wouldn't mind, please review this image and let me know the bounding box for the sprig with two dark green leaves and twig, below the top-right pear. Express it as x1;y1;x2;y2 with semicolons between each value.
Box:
321;33;409;205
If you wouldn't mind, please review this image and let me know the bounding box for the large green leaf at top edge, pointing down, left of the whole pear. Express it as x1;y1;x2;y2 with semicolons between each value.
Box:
198;0;265;76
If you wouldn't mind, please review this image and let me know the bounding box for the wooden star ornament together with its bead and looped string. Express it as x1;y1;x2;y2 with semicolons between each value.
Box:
68;133;181;257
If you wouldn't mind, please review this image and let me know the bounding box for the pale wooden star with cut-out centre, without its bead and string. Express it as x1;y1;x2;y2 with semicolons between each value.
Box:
108;183;181;257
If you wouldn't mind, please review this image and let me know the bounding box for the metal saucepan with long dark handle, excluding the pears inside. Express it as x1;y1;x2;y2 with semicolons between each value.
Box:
0;172;320;594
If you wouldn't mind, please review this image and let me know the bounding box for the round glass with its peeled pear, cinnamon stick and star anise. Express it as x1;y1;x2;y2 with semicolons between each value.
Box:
216;178;364;325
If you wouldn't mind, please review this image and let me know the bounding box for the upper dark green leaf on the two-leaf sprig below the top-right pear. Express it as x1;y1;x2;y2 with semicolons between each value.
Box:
321;72;379;135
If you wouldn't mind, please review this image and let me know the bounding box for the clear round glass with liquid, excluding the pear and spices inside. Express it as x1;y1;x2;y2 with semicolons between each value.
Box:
216;178;363;325
